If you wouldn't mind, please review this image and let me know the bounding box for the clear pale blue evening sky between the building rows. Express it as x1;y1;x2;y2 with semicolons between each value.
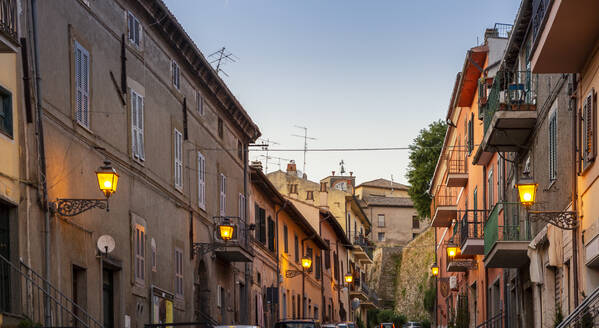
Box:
165;0;520;183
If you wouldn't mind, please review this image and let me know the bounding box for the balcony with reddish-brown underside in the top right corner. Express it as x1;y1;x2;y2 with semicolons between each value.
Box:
531;0;599;73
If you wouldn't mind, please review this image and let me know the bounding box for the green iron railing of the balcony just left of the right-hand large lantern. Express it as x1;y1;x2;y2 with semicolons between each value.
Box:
484;202;531;255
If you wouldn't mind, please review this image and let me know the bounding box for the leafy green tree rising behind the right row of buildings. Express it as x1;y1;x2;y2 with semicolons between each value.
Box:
406;120;447;218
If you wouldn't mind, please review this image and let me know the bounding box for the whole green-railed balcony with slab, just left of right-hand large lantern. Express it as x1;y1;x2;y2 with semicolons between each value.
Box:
484;203;531;268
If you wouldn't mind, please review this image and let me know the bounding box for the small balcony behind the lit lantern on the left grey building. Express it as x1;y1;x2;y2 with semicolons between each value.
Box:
214;219;254;262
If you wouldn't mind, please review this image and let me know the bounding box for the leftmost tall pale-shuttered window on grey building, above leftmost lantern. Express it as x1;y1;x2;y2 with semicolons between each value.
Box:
75;41;90;128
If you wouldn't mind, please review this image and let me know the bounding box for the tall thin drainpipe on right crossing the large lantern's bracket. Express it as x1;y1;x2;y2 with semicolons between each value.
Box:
569;74;580;308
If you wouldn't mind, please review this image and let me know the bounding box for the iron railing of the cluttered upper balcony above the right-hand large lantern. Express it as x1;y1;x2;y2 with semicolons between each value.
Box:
480;71;538;133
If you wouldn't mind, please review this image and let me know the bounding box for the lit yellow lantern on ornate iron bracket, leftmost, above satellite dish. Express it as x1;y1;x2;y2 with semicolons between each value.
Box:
49;160;119;216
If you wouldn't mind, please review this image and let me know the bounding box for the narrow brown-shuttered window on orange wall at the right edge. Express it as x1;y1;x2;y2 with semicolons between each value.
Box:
582;89;597;168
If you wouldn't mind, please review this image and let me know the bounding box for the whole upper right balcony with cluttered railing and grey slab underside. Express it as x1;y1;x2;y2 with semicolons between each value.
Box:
474;71;538;165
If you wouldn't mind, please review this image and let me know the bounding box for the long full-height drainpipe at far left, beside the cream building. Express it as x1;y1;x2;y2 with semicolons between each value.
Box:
31;0;52;326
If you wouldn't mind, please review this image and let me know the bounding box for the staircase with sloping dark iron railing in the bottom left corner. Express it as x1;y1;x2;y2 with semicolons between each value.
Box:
0;255;103;328
